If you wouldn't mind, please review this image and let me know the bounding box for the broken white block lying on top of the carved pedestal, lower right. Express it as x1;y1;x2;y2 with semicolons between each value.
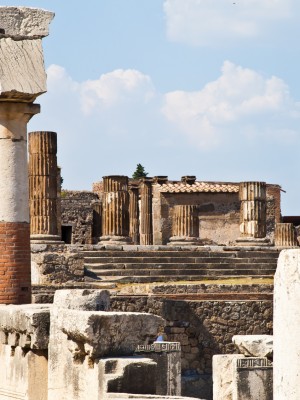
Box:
232;335;273;358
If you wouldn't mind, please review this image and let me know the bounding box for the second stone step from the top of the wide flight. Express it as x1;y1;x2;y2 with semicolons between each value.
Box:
84;257;277;264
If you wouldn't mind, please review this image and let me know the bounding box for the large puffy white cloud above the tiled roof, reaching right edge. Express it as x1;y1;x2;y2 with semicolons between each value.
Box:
163;61;300;148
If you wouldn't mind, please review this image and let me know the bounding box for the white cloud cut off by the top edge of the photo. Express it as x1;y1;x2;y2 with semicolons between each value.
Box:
164;0;296;46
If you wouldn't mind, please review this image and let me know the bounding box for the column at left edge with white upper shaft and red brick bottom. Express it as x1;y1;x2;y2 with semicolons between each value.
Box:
0;101;40;304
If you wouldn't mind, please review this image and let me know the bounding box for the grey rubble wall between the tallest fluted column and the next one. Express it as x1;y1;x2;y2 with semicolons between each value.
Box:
61;190;99;244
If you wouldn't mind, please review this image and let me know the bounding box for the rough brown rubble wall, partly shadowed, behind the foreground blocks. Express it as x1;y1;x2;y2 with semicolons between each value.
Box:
111;296;273;400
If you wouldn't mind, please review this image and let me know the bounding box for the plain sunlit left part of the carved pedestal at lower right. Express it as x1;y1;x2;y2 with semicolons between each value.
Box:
213;354;244;400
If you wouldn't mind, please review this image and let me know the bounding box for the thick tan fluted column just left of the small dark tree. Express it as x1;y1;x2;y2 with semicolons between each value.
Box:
100;175;130;244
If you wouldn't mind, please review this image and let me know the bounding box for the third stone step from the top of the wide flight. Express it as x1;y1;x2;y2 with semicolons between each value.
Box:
84;262;277;272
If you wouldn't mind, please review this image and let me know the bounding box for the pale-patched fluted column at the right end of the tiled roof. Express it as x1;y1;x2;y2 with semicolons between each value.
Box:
238;182;266;241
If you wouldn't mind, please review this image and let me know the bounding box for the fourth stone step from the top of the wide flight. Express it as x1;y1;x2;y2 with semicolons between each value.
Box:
90;269;275;278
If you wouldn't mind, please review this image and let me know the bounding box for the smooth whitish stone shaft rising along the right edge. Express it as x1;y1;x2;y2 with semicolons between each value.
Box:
274;250;300;400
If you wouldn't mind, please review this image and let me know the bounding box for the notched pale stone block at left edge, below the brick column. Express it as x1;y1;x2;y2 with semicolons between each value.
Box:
0;304;51;349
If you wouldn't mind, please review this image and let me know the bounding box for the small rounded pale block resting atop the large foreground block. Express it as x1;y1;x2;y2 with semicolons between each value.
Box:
54;289;110;311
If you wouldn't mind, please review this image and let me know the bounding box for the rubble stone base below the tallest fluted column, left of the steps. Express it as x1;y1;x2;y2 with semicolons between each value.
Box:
31;244;84;285
